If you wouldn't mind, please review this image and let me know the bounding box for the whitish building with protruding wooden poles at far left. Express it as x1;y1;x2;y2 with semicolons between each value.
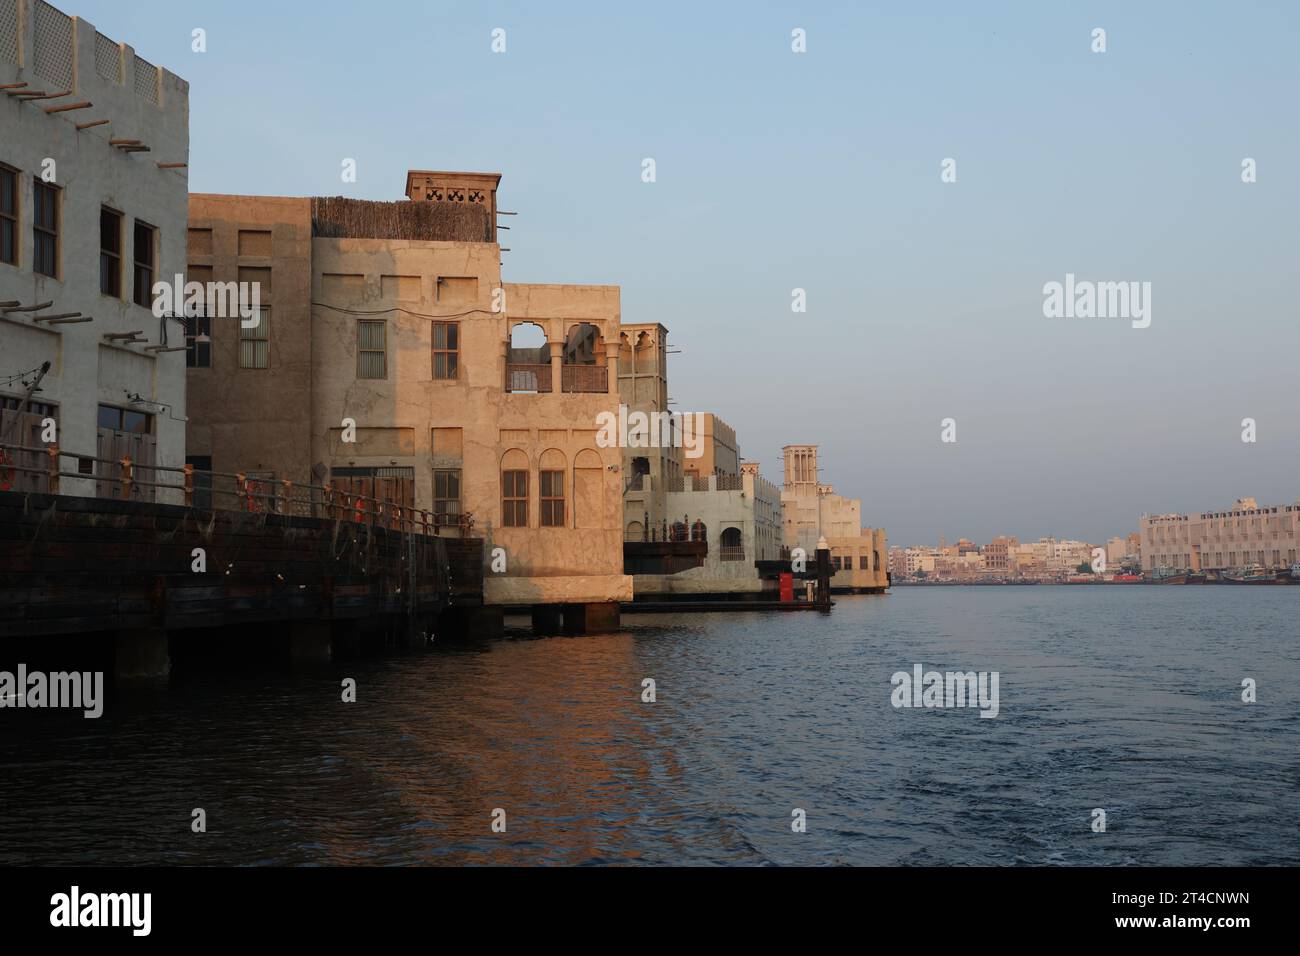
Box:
0;0;190;503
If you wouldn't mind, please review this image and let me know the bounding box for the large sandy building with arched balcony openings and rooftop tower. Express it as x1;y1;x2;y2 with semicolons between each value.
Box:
189;170;632;630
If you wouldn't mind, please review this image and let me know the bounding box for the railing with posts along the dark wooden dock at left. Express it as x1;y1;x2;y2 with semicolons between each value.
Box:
0;444;475;537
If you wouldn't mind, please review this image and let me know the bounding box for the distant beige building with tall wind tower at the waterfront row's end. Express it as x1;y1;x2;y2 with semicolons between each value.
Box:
781;445;889;591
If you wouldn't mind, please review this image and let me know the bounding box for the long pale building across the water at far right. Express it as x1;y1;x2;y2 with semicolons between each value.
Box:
1138;498;1300;571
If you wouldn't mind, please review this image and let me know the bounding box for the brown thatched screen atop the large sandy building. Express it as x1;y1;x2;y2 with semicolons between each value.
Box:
312;196;495;242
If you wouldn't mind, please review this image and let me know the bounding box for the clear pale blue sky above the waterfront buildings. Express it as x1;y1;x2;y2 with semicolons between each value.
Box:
68;0;1300;545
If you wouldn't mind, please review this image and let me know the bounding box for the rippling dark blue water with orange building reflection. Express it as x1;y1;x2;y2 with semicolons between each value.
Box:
0;587;1300;865
